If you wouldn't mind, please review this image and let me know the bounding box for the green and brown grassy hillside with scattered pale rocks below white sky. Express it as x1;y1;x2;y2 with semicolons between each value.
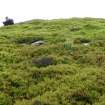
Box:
0;18;105;105
